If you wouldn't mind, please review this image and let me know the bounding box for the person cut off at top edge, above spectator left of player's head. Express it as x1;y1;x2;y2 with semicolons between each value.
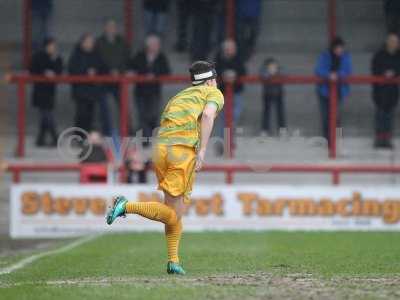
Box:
143;0;170;36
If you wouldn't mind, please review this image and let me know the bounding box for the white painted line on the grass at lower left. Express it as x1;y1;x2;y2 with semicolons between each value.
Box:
0;235;99;275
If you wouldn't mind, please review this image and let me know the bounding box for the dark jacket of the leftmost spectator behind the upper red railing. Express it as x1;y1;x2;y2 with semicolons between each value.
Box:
29;51;63;109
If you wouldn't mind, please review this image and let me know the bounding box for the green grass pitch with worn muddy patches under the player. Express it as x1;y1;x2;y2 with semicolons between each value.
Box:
0;232;400;300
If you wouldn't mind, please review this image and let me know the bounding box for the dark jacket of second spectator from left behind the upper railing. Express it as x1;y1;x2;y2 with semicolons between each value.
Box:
68;46;107;100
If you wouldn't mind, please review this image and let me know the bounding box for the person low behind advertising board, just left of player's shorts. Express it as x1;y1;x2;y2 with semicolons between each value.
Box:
125;148;150;183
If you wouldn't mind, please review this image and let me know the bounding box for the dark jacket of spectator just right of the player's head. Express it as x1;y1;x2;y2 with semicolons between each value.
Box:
215;52;246;93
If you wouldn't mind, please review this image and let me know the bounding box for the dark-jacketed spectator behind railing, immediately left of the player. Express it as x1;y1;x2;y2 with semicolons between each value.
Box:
129;35;170;144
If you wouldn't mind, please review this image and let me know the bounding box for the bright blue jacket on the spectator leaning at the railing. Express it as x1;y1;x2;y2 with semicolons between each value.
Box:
315;50;352;100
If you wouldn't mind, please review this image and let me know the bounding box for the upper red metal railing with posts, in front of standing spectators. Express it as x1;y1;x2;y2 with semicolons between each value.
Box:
9;74;400;158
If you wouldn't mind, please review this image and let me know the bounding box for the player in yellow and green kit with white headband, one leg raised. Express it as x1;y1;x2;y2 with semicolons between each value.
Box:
107;61;224;275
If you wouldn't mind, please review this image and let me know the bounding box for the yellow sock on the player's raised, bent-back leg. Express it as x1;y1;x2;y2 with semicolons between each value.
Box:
125;201;178;225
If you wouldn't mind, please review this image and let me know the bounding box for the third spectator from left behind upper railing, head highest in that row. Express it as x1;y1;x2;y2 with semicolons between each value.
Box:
96;19;130;136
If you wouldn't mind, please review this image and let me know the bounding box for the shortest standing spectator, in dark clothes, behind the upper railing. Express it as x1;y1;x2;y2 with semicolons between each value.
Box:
260;58;286;135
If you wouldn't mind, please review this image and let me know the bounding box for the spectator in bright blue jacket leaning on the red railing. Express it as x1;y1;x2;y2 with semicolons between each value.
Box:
315;37;352;145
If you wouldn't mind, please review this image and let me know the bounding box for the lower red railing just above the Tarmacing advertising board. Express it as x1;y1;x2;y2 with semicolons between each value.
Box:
6;163;400;185
